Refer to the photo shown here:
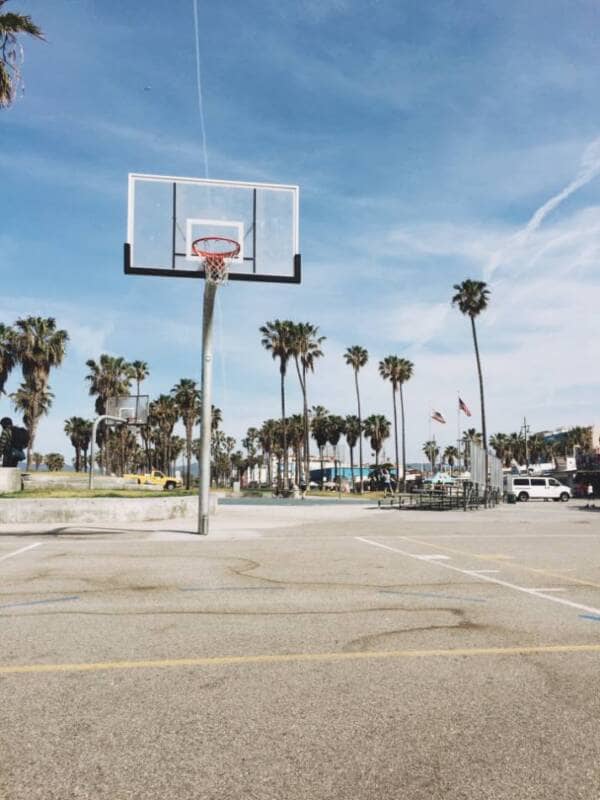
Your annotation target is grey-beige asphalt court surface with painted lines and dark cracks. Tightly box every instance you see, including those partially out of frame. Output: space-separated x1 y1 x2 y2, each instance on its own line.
0 503 600 800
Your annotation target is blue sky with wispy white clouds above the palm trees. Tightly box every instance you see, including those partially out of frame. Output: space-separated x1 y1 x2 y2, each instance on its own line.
0 0 600 460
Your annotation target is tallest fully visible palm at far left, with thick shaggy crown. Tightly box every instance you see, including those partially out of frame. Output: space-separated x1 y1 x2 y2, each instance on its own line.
13 317 69 469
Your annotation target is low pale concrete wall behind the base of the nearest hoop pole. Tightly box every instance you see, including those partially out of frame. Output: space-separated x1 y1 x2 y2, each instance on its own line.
0 495 217 524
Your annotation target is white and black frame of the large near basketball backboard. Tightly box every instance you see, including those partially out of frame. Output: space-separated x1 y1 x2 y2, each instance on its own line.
123 173 302 284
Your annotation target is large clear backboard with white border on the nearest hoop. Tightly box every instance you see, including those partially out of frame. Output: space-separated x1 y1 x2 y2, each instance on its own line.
125 174 301 283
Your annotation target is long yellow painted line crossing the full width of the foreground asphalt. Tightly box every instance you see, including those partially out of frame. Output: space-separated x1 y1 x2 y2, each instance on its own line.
0 644 600 675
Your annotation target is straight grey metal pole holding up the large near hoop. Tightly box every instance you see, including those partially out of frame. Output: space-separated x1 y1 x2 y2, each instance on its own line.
198 281 217 536
